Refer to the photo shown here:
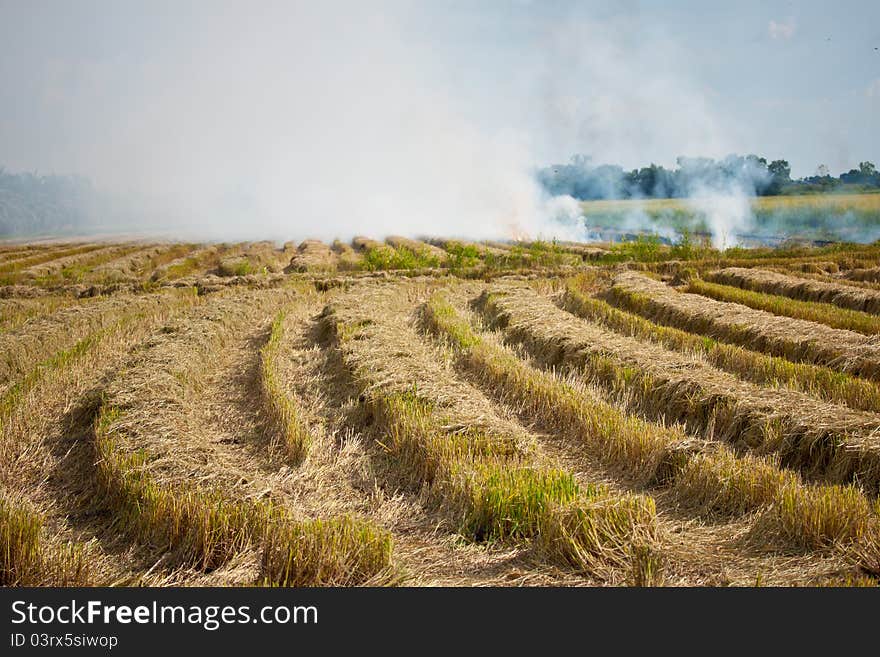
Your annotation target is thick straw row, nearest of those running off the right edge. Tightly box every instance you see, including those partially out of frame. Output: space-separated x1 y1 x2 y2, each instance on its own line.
481 287 880 493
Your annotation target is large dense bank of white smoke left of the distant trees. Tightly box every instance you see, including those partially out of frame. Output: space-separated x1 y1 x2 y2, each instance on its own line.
3 1 541 239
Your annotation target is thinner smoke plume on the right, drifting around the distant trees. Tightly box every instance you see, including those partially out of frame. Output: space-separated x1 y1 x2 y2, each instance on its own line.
524 12 759 246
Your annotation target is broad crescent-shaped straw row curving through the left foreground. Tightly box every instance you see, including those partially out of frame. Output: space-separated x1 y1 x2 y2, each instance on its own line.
96 288 393 586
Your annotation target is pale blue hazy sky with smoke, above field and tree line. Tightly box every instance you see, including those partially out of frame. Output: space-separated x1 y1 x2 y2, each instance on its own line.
0 0 880 236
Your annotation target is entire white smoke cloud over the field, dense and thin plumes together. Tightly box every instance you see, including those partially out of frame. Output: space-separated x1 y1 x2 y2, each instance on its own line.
0 2 784 239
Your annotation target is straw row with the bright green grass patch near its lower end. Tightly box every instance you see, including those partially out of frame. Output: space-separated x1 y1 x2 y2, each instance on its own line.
322 287 654 575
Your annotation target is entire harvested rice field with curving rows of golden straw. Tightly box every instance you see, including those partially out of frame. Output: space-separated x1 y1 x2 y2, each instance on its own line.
0 236 880 586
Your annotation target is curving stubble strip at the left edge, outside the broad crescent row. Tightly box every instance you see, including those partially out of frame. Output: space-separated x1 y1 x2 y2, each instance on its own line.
0 292 197 585
